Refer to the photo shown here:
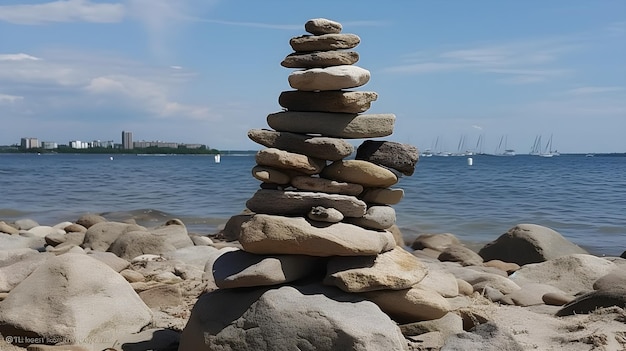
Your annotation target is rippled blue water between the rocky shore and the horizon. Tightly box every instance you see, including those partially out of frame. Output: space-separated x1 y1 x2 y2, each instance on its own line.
0 154 626 255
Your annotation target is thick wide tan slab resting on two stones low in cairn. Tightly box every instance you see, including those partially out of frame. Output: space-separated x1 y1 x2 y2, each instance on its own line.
239 214 396 257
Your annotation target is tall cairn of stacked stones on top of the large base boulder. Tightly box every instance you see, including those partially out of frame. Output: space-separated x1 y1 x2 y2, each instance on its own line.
182 19 448 349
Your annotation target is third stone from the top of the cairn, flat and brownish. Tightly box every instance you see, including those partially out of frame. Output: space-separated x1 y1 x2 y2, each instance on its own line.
280 51 359 68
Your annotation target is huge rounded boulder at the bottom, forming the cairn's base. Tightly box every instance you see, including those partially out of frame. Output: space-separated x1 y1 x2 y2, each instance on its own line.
179 285 406 351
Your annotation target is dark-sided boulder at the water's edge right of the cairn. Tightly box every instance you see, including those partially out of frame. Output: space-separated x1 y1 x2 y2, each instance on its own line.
478 224 587 265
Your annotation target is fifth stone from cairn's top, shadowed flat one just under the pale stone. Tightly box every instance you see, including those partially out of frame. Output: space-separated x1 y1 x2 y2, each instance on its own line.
278 90 378 113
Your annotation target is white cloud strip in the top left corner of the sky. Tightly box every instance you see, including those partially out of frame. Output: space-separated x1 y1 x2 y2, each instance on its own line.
0 0 125 25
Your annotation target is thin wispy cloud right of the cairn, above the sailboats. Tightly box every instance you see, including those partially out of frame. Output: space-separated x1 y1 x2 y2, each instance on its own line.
385 39 579 84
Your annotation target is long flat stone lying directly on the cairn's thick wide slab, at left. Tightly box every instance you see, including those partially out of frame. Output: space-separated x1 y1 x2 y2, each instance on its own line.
246 189 367 217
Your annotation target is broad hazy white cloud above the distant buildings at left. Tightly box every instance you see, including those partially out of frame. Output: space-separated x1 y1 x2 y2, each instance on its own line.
0 52 215 120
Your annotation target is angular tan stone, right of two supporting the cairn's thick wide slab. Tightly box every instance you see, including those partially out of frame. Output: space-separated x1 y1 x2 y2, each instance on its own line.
324 246 428 292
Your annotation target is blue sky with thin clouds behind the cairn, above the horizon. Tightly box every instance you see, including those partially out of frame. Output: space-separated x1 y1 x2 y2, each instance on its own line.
0 0 626 153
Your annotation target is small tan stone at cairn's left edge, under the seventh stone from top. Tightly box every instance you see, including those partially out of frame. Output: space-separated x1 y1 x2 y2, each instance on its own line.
256 148 326 174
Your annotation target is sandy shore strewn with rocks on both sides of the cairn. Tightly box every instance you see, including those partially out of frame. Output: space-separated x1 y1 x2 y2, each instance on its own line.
0 214 626 350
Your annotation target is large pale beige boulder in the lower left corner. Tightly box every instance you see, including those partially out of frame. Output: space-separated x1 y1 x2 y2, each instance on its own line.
0 254 152 343
